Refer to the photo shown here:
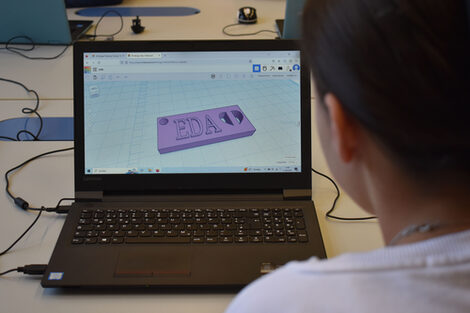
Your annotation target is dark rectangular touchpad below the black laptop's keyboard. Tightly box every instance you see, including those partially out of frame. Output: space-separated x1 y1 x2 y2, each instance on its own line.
114 250 191 277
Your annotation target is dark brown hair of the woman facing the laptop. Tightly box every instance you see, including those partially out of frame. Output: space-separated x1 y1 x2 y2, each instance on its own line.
303 0 470 178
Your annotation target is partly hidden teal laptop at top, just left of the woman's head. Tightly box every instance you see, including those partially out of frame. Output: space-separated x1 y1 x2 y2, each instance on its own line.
276 0 305 39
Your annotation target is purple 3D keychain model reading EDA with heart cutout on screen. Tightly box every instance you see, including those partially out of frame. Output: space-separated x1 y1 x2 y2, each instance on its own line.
157 105 256 154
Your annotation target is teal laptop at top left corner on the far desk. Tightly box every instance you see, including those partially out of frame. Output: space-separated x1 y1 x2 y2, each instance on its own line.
0 0 93 45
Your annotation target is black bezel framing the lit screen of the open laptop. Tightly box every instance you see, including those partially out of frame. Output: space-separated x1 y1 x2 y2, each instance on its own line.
74 40 311 193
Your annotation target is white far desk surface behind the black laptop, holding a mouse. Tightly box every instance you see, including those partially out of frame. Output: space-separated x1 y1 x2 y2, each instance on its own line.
0 0 285 99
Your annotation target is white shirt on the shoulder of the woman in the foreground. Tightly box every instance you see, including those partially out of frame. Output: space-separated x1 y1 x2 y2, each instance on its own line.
226 231 470 313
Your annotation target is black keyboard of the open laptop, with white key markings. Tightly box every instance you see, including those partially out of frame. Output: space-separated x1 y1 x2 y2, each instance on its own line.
72 208 308 245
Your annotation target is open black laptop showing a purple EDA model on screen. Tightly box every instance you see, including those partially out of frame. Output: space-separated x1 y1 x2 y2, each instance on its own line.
42 40 325 288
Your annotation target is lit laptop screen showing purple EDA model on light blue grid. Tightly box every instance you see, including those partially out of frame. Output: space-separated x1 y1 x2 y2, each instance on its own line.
82 50 302 175
